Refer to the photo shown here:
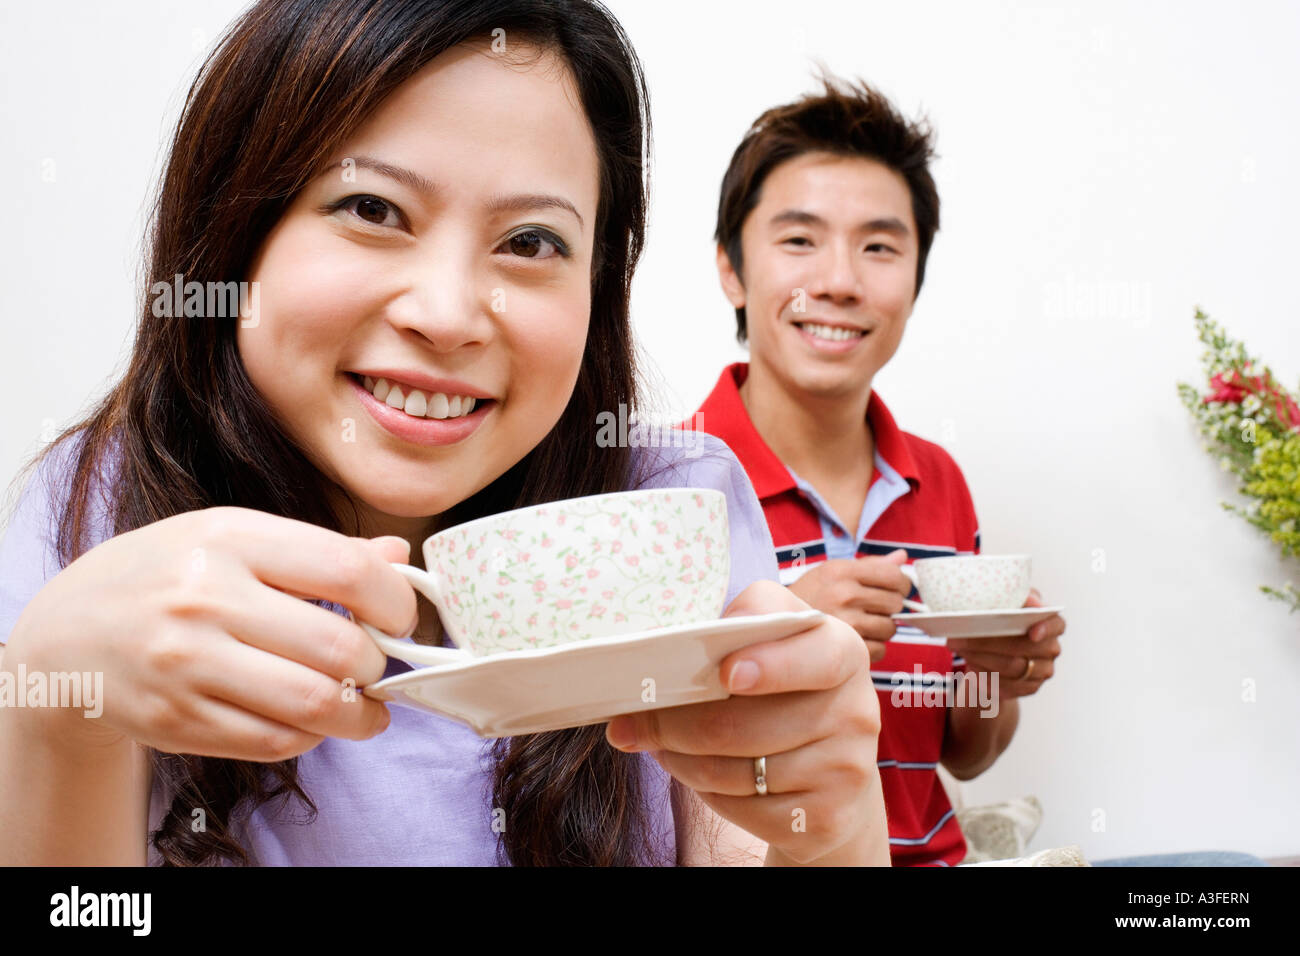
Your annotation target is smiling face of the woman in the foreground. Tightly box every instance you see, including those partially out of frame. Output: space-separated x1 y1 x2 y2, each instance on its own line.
238 47 599 540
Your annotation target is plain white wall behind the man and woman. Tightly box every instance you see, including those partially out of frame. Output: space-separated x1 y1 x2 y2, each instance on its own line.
0 0 1300 858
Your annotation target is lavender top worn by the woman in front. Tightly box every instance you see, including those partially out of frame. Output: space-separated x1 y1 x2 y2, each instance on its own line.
0 433 776 866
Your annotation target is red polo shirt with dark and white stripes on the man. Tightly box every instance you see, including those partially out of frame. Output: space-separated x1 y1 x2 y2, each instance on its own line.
686 363 979 866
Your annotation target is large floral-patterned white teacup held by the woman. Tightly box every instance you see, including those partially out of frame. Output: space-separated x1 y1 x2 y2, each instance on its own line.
358 488 731 663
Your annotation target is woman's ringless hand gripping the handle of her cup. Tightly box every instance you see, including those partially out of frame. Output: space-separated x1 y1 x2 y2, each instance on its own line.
5 507 416 762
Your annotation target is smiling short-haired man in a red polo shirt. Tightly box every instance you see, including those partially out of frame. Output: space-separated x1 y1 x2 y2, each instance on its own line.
697 81 1065 865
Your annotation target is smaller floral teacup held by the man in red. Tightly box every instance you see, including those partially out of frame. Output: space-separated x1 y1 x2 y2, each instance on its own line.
900 554 1030 613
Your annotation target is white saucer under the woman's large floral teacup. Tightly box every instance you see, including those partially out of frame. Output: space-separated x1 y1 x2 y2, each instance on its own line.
365 610 824 737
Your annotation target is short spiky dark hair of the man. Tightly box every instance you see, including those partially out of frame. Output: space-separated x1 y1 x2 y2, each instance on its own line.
714 74 939 345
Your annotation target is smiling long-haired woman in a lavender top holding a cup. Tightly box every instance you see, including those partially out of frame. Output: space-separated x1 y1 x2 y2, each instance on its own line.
0 0 888 865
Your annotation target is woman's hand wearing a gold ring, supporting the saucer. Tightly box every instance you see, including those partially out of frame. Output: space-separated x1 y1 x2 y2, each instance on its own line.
606 581 889 865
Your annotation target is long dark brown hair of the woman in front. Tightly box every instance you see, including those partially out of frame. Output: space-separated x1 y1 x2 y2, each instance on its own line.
26 0 671 865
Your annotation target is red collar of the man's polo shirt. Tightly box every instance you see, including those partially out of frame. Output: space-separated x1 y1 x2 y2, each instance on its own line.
686 362 920 498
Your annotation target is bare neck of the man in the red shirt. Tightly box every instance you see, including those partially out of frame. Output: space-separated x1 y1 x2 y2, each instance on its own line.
740 363 875 484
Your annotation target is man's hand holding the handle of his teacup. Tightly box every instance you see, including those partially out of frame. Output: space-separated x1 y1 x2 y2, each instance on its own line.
790 548 911 662
